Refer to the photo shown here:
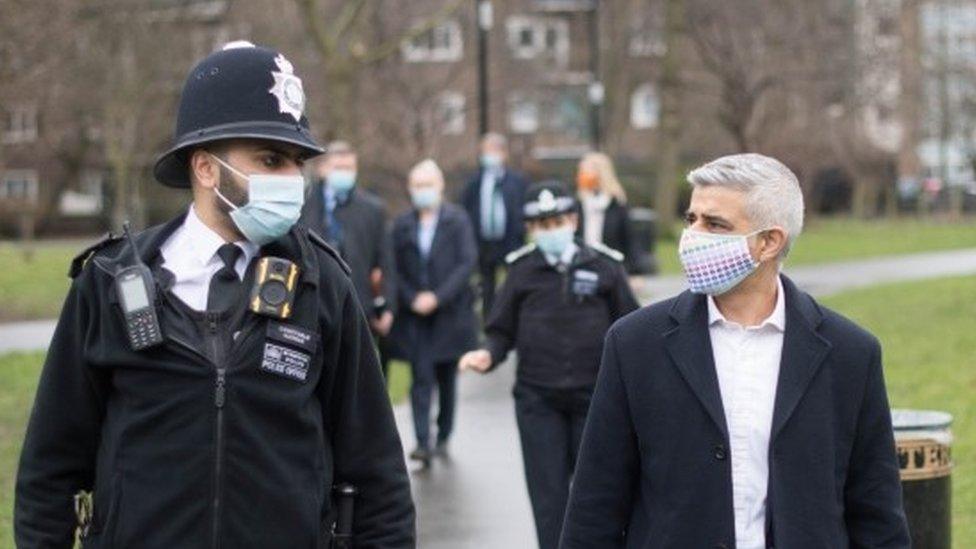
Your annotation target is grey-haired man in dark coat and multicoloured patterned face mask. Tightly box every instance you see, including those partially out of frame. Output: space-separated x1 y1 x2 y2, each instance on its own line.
560 154 910 549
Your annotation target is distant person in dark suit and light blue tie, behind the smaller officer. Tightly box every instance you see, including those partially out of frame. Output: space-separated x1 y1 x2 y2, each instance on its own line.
461 133 528 318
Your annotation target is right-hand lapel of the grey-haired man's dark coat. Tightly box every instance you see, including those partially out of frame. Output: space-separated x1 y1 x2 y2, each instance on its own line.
770 276 831 440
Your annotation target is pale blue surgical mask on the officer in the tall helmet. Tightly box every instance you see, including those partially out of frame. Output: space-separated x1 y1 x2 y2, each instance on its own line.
211 155 305 246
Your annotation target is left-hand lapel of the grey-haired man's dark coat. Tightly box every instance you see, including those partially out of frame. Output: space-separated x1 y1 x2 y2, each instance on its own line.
665 292 729 439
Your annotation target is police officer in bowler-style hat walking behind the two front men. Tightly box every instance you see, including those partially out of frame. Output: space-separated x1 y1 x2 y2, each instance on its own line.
459 181 637 549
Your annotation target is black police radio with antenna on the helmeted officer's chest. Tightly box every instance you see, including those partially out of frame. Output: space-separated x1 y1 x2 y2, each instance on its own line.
115 221 163 351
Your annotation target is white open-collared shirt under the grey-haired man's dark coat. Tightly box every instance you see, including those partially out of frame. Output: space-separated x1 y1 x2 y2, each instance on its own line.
708 280 786 549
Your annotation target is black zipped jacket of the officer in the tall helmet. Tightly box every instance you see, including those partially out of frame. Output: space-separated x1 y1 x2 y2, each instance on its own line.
14 214 414 549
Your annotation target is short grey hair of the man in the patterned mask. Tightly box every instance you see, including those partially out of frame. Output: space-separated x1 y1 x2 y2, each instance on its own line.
688 153 803 258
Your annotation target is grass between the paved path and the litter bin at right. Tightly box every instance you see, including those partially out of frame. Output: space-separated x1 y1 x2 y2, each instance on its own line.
824 277 976 548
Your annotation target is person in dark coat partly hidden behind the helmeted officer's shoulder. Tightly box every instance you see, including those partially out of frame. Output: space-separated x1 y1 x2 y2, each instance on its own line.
301 141 396 376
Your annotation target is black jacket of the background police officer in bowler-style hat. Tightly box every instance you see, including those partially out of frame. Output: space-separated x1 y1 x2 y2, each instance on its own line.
485 242 638 389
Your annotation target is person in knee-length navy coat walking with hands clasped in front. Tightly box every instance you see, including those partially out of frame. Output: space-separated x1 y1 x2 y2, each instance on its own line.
393 160 477 465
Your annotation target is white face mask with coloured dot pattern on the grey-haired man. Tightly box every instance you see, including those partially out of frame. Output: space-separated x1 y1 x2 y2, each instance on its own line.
678 229 765 295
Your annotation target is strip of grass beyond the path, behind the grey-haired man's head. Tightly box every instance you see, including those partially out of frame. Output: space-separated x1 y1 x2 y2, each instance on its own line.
657 218 976 274
